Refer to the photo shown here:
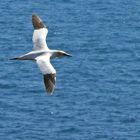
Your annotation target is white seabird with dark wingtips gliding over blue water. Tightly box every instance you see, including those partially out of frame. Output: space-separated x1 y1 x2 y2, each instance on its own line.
11 14 71 95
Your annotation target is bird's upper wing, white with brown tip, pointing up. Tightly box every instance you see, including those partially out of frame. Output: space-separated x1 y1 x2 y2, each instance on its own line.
32 14 49 51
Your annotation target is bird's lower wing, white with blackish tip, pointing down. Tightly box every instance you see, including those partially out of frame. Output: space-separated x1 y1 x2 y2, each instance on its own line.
36 55 56 95
